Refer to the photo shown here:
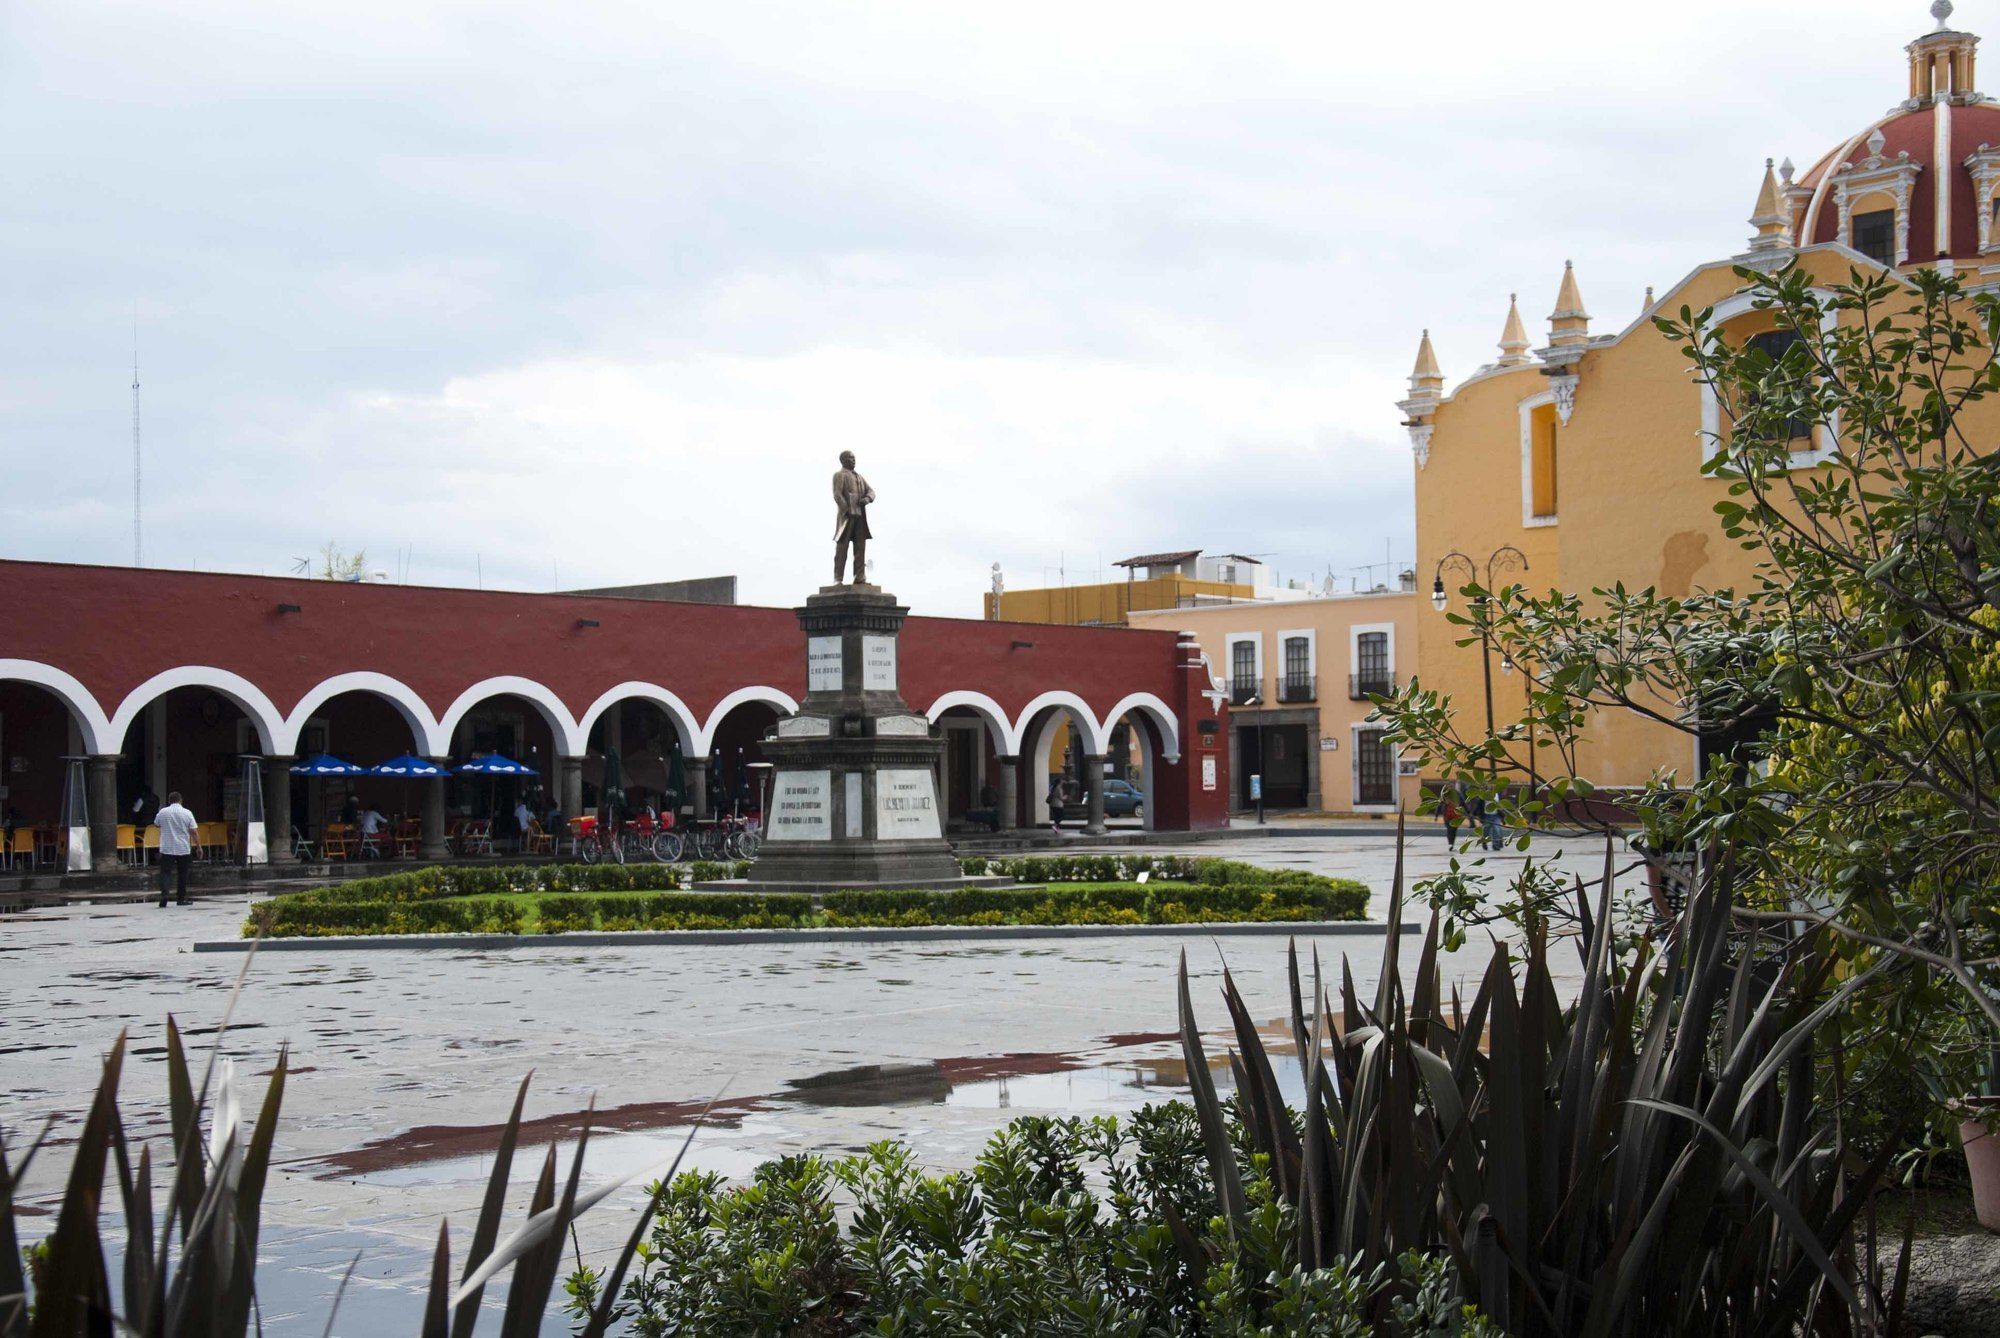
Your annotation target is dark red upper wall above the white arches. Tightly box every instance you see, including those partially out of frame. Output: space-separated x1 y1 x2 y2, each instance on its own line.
0 562 1228 828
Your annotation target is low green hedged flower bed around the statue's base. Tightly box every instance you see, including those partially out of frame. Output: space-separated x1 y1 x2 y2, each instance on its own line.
242 856 1368 938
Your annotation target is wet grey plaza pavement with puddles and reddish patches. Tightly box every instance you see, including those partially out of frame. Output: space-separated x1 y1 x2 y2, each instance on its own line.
0 832 1640 1334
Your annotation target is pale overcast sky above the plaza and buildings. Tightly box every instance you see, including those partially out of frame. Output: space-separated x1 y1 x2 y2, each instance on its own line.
0 0 1944 616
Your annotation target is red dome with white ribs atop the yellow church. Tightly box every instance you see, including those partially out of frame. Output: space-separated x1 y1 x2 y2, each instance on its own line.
1798 100 2000 264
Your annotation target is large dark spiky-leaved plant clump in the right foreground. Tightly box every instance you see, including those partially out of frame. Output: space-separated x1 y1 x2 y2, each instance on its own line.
1180 828 1900 1338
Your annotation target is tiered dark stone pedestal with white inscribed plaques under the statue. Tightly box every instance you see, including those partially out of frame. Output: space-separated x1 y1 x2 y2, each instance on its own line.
734 586 966 892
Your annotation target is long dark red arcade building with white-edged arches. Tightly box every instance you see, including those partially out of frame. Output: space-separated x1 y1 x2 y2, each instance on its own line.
0 562 1230 870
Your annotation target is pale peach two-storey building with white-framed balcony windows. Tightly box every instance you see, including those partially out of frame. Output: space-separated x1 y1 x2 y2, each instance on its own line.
1130 586 1422 814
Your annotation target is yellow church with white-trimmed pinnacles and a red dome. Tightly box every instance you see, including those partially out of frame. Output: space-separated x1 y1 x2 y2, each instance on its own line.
1398 0 2000 786
